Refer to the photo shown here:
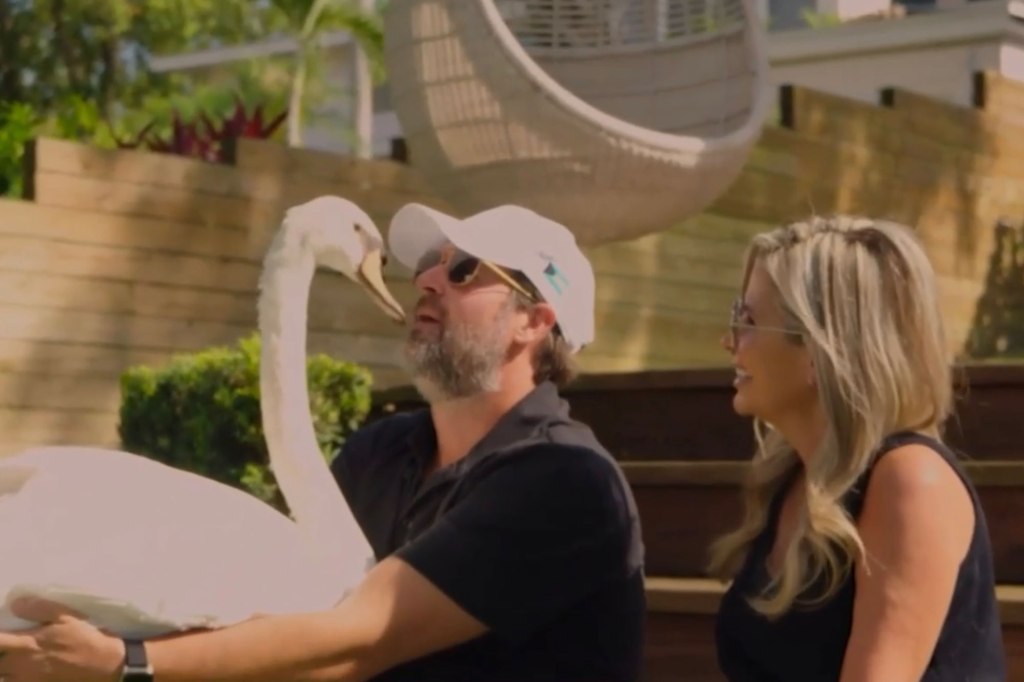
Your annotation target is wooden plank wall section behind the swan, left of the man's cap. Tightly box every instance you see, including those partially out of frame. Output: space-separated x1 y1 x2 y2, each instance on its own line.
0 139 444 453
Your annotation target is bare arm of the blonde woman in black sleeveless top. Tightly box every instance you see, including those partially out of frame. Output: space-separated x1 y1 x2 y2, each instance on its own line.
840 444 975 682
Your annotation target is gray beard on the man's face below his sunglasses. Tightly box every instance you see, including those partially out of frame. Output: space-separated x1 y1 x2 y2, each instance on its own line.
402 301 513 402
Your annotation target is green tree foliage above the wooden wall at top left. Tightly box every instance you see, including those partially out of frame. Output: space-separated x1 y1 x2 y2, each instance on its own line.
0 0 383 153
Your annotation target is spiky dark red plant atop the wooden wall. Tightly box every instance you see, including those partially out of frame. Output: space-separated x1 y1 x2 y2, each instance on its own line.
117 97 288 163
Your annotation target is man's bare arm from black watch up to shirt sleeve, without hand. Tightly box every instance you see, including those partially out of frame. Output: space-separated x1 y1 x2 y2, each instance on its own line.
105 558 486 682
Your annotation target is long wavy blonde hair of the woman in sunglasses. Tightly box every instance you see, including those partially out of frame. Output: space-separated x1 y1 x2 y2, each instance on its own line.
710 216 953 617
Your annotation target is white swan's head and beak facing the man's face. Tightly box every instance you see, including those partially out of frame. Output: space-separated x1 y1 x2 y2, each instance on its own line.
285 196 406 323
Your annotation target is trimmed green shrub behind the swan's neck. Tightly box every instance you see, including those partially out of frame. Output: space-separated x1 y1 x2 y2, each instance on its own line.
118 334 372 510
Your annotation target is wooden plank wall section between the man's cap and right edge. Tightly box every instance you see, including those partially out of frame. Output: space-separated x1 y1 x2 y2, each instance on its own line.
592 74 1024 369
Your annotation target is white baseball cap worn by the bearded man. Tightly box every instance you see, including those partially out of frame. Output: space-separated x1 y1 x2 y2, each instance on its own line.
388 204 595 352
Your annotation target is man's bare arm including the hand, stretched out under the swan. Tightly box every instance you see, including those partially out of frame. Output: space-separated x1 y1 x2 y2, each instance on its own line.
0 558 486 682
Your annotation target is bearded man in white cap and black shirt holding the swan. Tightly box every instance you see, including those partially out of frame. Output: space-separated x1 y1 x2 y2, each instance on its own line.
0 199 645 682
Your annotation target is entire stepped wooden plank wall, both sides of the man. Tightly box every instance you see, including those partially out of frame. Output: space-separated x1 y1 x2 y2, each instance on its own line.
0 74 1024 454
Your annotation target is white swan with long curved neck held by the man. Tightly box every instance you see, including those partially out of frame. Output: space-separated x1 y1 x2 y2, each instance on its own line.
0 197 403 637
